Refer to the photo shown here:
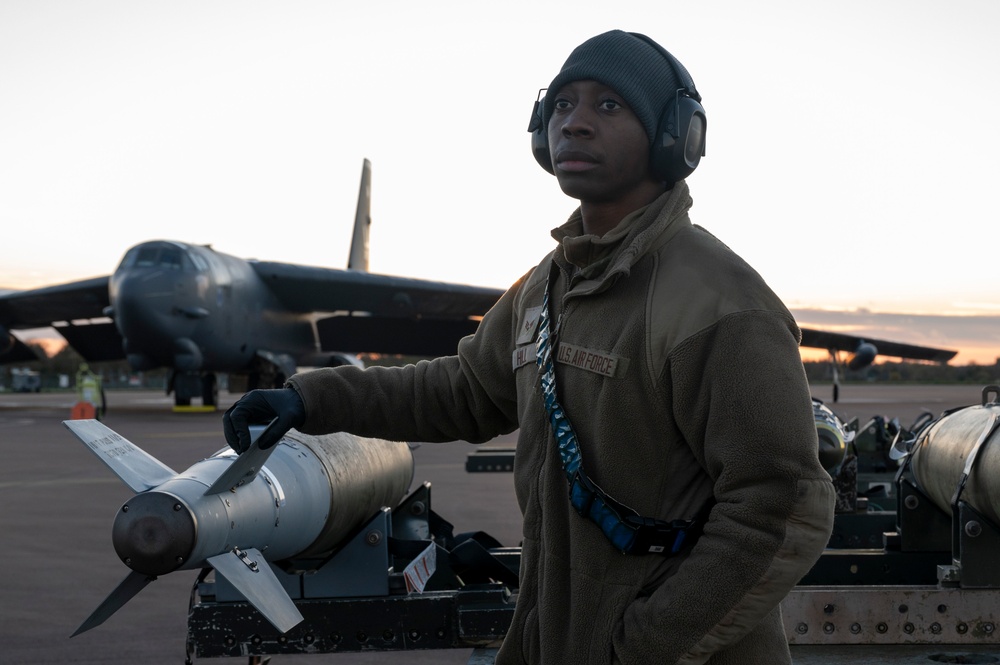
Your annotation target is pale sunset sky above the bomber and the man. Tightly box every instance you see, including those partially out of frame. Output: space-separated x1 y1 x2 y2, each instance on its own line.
0 0 1000 363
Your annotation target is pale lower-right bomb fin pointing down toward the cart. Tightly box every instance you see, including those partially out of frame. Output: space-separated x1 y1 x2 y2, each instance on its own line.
208 544 304 633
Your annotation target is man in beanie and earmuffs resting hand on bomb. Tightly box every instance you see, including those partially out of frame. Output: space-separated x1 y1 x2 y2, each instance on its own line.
225 30 834 665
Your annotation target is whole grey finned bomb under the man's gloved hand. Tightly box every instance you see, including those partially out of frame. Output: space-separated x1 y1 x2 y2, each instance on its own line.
63 420 414 636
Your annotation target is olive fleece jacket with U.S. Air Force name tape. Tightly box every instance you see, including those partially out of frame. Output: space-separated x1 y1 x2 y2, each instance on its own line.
289 182 834 665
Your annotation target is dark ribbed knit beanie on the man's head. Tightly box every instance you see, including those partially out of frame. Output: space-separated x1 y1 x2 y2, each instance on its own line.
542 30 682 145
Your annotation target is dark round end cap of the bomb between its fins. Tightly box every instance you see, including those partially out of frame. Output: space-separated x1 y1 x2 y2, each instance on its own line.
111 492 197 576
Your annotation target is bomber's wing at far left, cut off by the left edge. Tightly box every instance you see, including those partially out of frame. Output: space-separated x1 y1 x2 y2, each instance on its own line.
0 276 125 363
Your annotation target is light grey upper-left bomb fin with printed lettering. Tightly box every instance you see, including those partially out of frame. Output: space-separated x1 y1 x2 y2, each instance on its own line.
63 420 177 494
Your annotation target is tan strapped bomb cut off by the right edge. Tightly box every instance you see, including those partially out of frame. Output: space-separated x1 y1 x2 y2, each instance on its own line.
910 386 1000 524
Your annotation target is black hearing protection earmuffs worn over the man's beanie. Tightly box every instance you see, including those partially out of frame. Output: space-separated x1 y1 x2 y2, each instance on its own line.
528 37 707 184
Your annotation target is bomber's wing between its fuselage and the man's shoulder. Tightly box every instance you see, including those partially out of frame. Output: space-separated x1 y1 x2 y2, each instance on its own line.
252 262 503 355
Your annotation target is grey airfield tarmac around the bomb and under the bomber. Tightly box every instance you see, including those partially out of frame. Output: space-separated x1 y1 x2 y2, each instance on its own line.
0 385 1000 665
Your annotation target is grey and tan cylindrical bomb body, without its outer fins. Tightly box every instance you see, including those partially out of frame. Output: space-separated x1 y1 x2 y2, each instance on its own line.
112 432 413 575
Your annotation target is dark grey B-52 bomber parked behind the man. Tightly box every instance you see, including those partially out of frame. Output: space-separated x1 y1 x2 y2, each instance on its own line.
0 159 956 407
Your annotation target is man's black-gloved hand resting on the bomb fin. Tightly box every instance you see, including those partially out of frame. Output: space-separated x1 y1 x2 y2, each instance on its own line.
222 388 306 454
